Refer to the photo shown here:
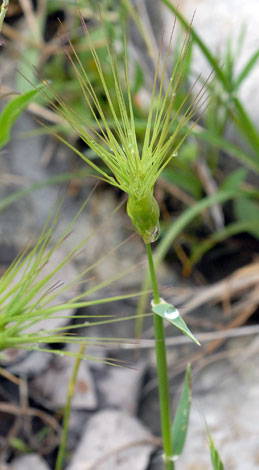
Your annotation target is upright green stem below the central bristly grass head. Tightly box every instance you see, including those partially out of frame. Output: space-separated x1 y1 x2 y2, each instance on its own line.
146 243 174 470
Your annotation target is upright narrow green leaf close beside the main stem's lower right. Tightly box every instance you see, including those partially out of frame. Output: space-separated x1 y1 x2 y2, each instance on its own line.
172 364 192 460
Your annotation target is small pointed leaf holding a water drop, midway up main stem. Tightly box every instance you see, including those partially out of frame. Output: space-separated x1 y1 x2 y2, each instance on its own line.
152 299 200 346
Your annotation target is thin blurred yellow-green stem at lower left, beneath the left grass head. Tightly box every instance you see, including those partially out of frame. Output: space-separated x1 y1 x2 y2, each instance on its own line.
55 343 86 470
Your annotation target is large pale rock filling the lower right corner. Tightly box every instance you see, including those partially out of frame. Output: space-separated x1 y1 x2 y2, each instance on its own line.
177 350 259 470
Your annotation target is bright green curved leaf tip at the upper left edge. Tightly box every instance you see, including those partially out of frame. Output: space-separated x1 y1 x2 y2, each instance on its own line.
0 88 39 148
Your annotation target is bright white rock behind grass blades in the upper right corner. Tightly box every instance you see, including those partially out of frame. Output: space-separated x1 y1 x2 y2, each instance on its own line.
163 0 259 124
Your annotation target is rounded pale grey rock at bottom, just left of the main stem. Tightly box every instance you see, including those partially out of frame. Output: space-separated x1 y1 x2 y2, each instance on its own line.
67 408 154 470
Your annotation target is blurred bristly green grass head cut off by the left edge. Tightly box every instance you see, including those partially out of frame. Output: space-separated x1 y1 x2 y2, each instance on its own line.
0 193 144 364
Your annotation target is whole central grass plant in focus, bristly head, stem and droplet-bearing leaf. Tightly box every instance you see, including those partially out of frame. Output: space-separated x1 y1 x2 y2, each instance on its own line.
42 6 211 470
